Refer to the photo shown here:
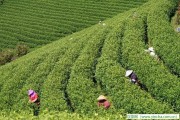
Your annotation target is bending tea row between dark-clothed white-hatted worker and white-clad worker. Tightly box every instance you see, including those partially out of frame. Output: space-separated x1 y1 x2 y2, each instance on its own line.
122 10 180 111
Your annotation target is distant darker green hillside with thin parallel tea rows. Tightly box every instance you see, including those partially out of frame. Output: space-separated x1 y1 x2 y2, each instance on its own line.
0 0 147 50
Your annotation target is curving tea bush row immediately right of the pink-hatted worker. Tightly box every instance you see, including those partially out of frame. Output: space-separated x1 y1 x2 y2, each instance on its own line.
41 25 100 111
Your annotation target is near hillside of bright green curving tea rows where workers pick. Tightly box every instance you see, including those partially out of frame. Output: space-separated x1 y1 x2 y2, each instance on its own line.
0 0 180 119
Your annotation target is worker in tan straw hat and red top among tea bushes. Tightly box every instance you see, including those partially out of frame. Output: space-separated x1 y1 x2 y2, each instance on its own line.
97 95 111 109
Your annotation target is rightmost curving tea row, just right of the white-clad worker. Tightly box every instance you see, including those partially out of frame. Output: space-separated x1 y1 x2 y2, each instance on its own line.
147 0 180 76
